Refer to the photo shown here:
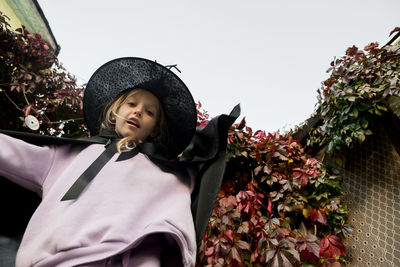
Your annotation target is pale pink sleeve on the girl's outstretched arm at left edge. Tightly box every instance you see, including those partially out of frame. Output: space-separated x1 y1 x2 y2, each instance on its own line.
0 134 55 195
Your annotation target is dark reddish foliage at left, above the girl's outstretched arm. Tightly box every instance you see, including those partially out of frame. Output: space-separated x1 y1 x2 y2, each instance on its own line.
0 12 86 136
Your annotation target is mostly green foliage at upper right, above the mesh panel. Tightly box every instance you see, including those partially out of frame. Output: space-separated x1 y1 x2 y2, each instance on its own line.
308 28 400 152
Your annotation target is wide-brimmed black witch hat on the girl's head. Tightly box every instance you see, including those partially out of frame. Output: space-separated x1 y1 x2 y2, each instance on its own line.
83 57 197 156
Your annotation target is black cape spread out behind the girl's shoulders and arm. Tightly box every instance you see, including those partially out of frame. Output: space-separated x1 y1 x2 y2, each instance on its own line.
0 105 240 258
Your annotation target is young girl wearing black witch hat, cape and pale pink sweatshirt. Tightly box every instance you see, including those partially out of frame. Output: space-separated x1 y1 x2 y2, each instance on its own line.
0 58 238 267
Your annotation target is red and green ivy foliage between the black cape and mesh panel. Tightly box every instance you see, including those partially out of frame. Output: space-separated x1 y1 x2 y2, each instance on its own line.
198 119 351 266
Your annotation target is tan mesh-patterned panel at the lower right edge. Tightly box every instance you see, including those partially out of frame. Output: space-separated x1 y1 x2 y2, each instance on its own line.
328 124 400 267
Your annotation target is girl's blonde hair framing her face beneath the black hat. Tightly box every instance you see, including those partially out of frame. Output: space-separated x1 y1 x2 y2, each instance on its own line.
100 88 167 153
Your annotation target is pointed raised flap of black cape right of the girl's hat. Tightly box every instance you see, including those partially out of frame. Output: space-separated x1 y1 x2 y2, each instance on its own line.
181 105 240 248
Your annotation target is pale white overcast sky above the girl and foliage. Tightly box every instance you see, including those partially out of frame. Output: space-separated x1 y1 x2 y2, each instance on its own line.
38 0 400 132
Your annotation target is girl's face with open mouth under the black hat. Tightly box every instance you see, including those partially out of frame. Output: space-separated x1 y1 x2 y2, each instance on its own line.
113 89 161 141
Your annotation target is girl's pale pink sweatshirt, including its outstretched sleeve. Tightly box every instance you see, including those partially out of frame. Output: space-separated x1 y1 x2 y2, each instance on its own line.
0 134 196 267
